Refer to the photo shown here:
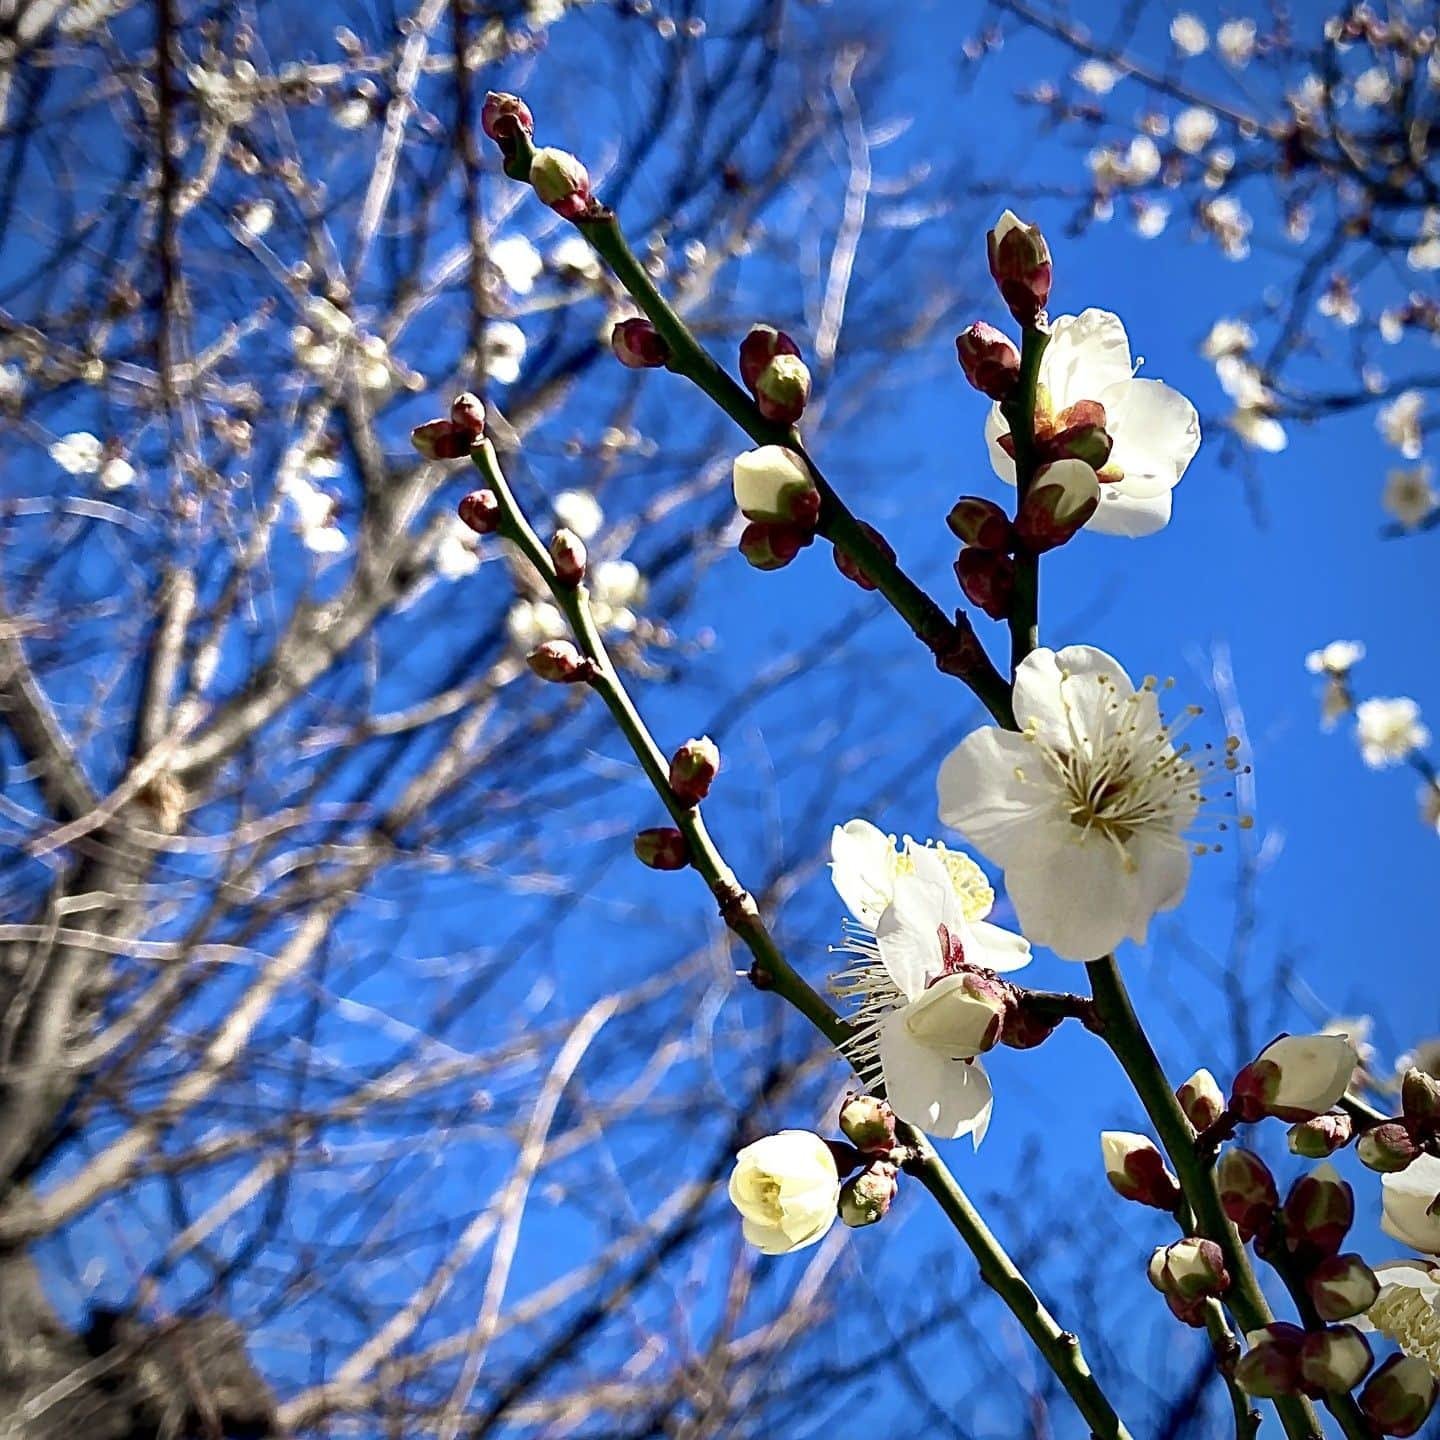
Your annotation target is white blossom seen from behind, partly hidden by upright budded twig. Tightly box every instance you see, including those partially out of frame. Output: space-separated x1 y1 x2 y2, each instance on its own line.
985 310 1200 536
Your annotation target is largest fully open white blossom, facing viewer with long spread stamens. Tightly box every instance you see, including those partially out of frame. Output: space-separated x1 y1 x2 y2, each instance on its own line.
937 645 1209 960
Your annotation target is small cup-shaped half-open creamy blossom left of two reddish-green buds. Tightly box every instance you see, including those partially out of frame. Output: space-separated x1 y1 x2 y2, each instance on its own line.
729 1130 840 1256
